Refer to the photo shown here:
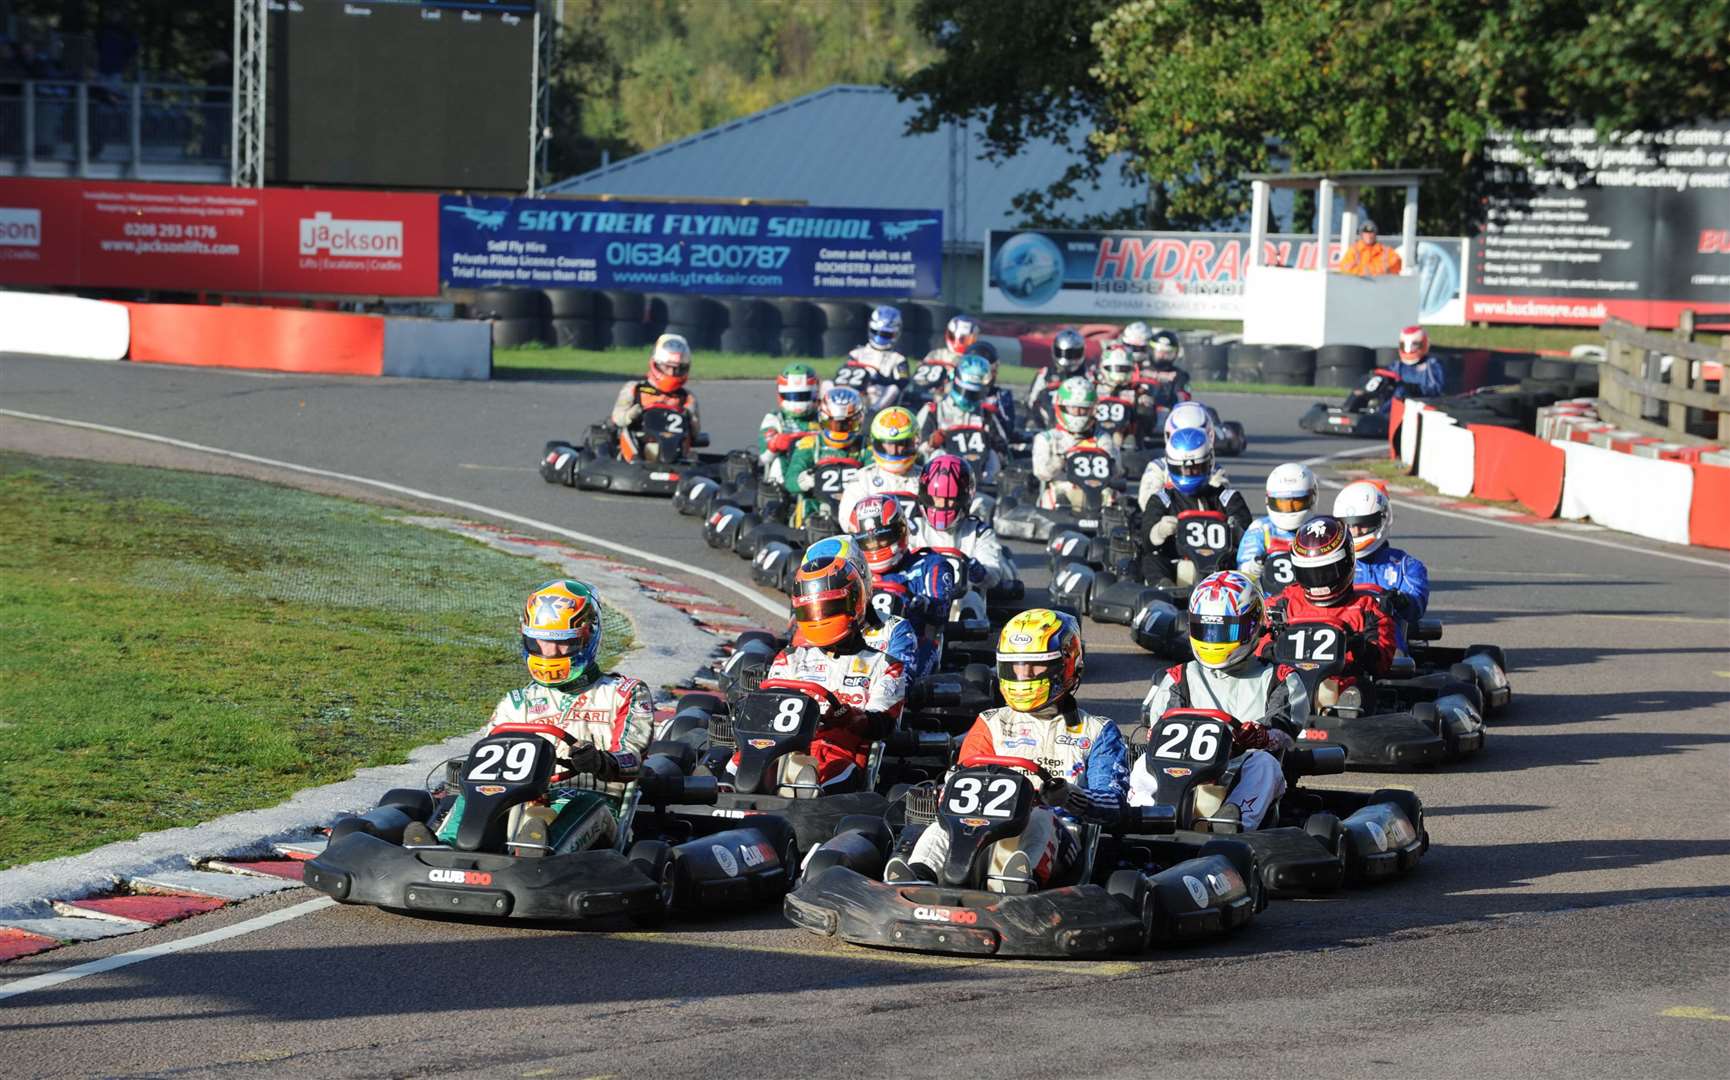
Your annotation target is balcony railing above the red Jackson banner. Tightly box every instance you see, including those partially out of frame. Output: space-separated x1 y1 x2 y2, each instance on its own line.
0 80 232 177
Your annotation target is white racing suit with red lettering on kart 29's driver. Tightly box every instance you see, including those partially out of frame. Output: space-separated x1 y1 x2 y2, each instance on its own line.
438 668 654 850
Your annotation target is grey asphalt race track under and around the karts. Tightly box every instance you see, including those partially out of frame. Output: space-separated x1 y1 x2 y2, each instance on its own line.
0 357 1730 1078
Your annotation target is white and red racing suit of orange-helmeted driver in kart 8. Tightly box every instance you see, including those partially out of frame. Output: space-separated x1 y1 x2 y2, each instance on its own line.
765 616 919 788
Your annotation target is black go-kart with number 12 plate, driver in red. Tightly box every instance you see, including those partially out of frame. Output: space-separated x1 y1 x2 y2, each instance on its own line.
1270 611 1484 765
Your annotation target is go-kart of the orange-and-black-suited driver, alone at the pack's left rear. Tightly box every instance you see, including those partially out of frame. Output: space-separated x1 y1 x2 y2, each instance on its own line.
540 405 727 495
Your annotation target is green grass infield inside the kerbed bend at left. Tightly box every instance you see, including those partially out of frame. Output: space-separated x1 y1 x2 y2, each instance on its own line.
0 453 630 867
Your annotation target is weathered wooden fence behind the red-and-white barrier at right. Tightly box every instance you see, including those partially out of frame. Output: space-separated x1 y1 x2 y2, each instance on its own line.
1599 312 1730 447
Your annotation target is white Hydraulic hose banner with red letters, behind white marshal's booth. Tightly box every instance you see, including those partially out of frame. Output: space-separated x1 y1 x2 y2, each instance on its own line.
984 228 1465 325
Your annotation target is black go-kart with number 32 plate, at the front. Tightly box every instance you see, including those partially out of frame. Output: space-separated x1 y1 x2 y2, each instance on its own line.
784 756 1265 957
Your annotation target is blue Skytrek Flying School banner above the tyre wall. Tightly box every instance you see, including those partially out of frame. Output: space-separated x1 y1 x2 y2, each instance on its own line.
439 196 943 298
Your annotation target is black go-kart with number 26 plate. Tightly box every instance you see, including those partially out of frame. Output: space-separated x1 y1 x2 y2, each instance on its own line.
1142 708 1429 897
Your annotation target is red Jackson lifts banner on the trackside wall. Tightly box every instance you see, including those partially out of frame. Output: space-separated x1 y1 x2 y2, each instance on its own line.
0 180 439 296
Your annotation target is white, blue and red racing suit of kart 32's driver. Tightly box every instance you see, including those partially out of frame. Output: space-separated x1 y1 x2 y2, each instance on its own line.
908 698 1130 888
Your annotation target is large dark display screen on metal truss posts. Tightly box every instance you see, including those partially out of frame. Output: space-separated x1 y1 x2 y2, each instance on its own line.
266 0 535 190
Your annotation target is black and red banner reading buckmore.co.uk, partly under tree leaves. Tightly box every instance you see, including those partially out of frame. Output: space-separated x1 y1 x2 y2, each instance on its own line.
1467 125 1730 327
